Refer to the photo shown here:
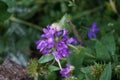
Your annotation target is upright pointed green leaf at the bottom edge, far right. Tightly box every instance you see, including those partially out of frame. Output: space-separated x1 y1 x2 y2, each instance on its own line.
99 63 112 80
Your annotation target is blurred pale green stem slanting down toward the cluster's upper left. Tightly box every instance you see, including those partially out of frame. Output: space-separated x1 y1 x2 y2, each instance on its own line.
10 16 42 31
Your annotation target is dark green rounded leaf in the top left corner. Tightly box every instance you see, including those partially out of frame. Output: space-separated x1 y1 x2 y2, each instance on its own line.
0 1 11 22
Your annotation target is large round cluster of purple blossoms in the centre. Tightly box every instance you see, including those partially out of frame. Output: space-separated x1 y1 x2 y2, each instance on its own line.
36 25 74 61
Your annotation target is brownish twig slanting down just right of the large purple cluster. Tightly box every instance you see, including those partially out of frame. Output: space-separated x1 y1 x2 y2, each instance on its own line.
67 20 82 43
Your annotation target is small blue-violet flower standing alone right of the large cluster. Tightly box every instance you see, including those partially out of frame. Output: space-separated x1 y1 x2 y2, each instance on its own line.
88 22 99 38
